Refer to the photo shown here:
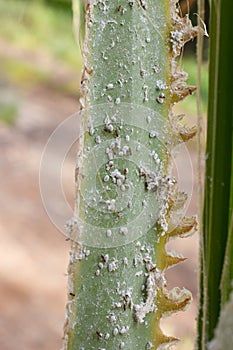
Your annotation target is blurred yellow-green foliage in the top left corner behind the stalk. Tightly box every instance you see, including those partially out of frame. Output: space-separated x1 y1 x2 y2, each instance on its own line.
0 0 81 69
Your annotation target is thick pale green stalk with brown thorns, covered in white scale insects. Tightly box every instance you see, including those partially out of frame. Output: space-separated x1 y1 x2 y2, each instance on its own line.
64 0 196 350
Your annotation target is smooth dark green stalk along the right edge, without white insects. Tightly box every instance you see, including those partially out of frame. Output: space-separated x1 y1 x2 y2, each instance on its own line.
199 0 233 349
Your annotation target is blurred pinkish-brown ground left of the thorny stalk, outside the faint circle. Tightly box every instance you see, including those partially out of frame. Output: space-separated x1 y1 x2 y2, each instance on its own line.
0 82 77 350
